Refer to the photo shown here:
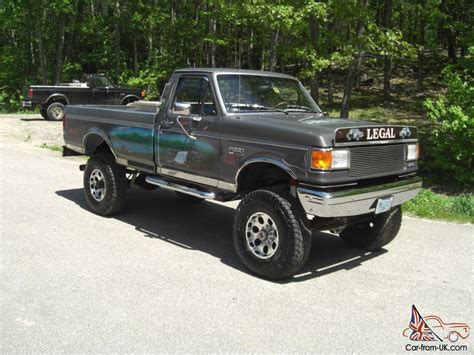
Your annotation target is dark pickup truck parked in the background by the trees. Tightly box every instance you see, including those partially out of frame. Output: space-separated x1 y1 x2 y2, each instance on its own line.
22 74 144 121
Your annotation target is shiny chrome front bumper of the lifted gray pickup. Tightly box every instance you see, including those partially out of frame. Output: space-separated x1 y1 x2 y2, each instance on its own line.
296 177 422 217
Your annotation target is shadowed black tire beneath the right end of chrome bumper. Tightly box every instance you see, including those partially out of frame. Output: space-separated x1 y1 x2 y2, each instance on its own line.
340 206 402 250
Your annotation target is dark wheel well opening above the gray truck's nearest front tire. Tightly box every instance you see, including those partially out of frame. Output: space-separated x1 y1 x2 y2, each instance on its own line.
237 163 292 193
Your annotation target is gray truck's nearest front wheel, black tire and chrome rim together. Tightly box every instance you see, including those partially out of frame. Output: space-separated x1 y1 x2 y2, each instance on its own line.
234 190 311 279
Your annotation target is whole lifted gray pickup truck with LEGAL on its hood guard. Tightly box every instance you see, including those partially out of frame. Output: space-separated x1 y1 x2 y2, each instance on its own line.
64 69 421 279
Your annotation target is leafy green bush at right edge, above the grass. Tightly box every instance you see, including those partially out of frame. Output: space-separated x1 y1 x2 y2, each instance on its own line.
423 63 474 190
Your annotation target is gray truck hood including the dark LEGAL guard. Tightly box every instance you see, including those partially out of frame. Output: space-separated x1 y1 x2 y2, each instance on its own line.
231 113 417 147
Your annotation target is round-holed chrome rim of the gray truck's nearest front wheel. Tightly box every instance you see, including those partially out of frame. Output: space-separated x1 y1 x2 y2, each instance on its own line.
245 212 279 259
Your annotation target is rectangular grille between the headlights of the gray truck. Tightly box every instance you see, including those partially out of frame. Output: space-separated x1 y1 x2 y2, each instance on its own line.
349 144 405 177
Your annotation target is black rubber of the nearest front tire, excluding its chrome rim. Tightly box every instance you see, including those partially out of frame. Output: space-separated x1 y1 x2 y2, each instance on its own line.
234 190 311 280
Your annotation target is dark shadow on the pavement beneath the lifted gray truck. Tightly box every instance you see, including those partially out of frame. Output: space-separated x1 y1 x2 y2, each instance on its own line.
56 188 386 284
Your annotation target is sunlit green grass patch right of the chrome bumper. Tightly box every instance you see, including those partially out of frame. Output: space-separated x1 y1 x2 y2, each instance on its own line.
402 189 474 223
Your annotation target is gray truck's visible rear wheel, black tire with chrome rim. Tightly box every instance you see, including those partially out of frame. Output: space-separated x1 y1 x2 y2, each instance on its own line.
84 154 127 216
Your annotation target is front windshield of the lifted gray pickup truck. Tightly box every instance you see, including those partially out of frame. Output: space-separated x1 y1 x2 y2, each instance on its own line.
217 74 321 113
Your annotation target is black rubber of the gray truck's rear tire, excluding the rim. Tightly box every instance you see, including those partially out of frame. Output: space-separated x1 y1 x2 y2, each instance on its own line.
84 153 128 216
